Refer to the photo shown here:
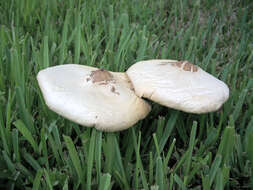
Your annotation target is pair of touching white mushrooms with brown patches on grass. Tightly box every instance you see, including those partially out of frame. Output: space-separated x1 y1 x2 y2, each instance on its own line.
37 60 229 131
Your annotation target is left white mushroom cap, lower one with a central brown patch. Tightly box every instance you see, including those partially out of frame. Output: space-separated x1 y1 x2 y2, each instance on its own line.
37 64 150 131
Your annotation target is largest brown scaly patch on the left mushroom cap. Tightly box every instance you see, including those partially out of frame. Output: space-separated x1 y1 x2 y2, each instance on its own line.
90 69 113 85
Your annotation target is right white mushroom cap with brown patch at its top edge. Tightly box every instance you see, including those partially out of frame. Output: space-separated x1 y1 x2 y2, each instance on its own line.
127 60 229 113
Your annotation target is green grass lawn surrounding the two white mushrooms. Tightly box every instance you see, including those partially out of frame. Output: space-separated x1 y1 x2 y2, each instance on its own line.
0 0 253 190
